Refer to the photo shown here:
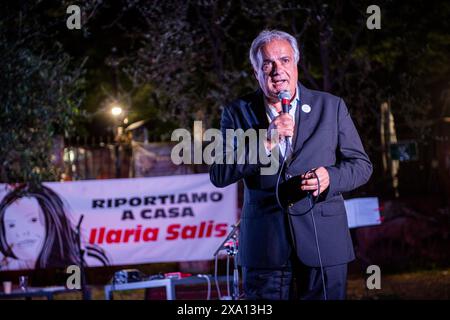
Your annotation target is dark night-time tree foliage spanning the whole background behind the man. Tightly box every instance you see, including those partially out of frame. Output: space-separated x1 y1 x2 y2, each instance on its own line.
0 0 450 190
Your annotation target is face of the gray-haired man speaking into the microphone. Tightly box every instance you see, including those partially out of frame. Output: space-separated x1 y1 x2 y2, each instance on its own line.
255 40 298 102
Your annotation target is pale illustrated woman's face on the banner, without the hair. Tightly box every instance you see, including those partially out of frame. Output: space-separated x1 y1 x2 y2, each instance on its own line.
4 198 45 260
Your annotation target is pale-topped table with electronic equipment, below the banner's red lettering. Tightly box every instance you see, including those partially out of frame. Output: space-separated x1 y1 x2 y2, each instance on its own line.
104 276 227 300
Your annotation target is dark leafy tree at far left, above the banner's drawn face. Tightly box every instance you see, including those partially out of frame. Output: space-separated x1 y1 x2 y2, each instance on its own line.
0 2 83 183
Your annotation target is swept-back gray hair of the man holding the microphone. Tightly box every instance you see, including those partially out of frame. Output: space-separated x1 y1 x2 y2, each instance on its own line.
250 30 300 70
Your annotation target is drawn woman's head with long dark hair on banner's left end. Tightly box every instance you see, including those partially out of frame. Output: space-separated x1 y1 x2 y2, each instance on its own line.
0 184 110 270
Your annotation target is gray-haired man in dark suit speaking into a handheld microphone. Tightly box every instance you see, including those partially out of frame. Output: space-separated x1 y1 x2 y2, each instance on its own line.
210 30 372 299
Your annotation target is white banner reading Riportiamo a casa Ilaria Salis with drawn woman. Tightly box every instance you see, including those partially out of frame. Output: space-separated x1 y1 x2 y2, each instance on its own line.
0 174 237 270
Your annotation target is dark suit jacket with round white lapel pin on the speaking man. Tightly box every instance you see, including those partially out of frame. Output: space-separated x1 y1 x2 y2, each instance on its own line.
210 84 372 268
